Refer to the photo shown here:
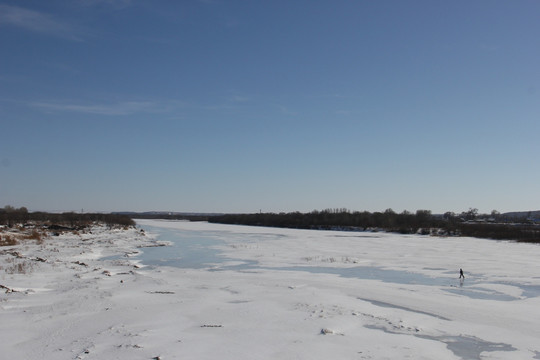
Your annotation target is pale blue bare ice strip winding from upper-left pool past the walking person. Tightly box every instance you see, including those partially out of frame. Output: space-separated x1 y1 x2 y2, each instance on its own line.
139 225 540 301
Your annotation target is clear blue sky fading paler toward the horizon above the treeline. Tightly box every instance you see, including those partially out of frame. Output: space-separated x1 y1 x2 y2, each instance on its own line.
0 0 540 213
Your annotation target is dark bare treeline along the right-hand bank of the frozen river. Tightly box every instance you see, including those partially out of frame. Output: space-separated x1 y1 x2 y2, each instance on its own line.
208 209 540 242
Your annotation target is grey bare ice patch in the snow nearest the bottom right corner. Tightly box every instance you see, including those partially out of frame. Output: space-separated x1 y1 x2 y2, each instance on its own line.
365 325 517 360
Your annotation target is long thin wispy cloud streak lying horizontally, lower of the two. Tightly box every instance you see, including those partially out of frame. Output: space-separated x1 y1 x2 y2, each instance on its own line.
31 101 167 116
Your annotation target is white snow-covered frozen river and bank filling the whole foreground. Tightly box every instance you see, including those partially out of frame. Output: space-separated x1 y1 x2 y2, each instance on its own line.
0 220 540 360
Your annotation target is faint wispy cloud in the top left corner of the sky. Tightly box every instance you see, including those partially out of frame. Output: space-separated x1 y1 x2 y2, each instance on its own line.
0 4 82 41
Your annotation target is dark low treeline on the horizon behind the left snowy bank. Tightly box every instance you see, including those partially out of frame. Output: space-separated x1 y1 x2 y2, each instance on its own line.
0 206 135 228
